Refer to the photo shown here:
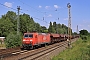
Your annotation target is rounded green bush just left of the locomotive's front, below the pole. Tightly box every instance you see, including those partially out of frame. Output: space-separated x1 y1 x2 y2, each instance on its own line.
5 33 21 48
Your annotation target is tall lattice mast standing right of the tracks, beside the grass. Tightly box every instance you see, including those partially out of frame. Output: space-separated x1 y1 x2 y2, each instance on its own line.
67 3 71 44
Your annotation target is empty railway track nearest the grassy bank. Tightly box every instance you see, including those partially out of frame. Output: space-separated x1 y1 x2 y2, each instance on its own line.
19 41 66 60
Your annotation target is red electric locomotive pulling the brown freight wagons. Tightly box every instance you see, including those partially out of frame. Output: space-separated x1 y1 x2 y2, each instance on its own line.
22 32 51 49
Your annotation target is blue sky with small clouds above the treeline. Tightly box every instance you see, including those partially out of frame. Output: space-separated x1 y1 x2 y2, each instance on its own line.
0 0 90 32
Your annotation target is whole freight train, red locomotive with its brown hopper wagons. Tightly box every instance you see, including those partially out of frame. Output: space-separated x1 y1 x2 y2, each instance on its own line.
22 32 79 49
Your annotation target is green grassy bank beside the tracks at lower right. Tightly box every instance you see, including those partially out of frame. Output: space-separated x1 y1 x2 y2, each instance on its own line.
52 37 90 60
